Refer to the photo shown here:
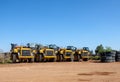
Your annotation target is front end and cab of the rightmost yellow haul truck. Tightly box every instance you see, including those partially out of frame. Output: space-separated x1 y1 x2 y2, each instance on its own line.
81 47 90 61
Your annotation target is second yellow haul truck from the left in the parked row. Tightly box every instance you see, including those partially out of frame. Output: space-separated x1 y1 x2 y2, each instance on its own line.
35 45 56 62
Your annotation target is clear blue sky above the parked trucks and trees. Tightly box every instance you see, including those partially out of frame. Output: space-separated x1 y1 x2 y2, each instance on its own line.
0 0 120 51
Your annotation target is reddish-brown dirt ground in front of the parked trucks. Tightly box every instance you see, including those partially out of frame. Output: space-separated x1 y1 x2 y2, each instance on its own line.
0 62 120 82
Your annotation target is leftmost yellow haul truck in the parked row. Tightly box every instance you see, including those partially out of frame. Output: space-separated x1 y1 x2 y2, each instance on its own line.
11 44 34 63
